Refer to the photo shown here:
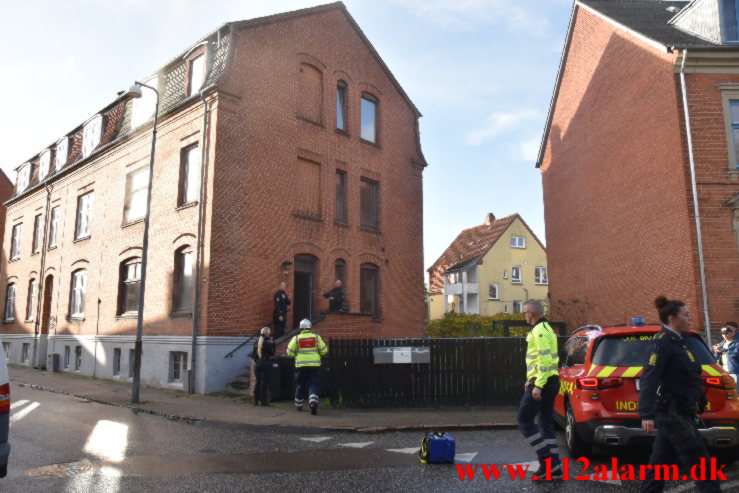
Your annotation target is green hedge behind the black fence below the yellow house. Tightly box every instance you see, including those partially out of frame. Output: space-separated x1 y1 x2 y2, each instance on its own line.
425 312 528 337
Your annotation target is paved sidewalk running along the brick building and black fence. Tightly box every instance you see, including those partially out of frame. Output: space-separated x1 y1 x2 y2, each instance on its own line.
8 365 516 433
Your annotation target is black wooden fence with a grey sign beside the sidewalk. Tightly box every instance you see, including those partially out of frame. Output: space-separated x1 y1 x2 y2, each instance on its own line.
328 337 567 407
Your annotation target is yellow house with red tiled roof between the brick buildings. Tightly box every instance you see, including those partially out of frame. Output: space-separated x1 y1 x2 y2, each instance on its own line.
428 213 549 319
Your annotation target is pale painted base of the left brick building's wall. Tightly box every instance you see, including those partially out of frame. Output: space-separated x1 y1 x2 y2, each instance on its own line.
0 334 252 394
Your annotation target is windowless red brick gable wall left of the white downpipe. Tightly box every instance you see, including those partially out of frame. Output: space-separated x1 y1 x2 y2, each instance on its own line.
541 9 702 327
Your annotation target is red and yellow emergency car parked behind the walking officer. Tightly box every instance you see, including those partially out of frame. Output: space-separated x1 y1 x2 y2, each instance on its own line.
554 324 739 457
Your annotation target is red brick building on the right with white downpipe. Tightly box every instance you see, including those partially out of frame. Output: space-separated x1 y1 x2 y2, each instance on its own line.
537 0 739 338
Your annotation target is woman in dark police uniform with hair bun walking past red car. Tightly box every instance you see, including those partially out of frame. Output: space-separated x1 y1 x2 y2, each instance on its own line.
639 296 721 493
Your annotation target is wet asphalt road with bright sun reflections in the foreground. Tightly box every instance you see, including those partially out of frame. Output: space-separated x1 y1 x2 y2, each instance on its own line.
0 386 739 493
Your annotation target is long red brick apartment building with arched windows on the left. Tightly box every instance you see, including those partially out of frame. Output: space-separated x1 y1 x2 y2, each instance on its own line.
2 2 426 392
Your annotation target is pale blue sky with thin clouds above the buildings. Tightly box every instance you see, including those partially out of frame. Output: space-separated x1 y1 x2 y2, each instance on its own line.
0 0 572 267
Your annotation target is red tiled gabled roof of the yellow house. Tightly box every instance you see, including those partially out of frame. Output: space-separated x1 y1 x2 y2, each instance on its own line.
428 214 544 272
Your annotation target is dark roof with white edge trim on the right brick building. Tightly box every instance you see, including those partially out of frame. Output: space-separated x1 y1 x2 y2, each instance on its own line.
536 0 739 168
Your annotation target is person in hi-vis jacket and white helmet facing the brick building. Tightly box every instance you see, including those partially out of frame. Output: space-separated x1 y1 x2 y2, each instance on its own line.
287 318 328 414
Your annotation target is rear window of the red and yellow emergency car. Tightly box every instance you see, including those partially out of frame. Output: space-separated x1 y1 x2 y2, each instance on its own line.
593 334 716 366
